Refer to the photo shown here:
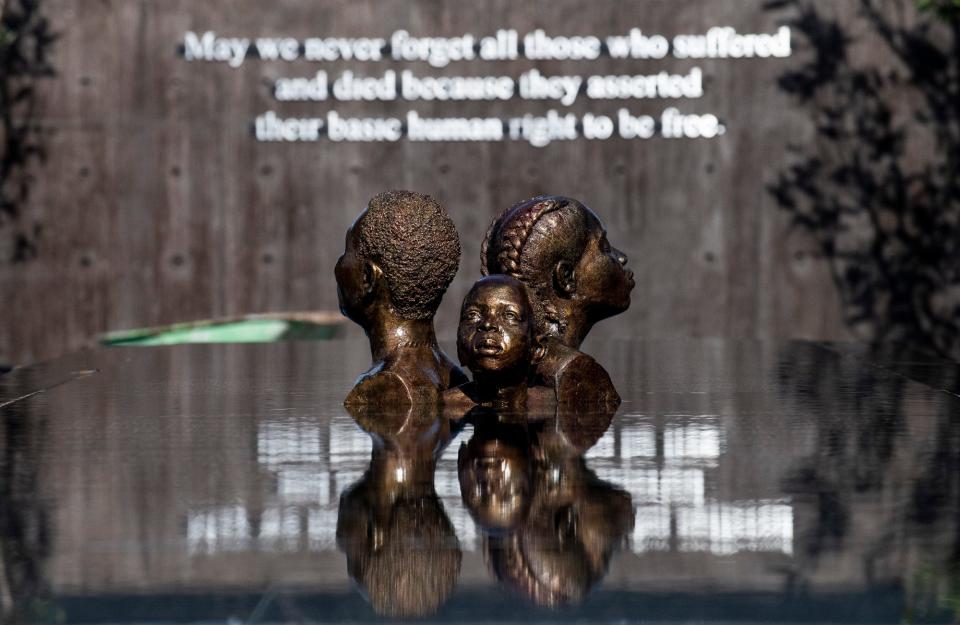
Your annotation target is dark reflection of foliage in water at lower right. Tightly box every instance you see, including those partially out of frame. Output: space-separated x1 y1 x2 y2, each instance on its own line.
777 343 960 623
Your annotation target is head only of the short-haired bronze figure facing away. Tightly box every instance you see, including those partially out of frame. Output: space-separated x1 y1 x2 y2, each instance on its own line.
335 191 460 327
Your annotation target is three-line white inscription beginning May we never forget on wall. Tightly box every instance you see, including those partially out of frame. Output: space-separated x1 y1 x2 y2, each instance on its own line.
182 26 792 147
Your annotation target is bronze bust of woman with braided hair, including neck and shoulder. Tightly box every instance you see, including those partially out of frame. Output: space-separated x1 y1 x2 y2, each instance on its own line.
481 196 634 403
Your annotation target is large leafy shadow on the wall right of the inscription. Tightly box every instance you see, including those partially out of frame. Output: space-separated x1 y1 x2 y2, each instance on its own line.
765 0 960 359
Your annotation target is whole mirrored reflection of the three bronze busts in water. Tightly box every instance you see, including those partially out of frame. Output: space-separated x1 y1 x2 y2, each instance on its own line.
337 392 634 617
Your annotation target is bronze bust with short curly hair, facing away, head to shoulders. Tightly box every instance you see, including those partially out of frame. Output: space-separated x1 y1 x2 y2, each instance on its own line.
335 191 467 404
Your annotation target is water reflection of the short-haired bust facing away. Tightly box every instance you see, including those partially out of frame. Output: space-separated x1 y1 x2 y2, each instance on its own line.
337 404 461 618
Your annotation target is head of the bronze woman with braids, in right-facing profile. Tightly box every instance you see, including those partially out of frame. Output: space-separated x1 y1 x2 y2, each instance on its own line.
481 196 634 347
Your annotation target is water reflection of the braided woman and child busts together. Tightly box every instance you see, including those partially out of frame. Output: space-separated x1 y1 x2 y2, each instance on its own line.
458 408 634 607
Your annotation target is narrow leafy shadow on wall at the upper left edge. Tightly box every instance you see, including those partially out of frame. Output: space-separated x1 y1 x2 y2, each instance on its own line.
0 0 56 263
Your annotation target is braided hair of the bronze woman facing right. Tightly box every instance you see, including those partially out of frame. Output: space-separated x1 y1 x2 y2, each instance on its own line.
480 195 587 336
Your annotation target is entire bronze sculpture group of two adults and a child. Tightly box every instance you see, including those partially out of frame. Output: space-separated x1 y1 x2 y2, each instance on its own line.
336 191 634 414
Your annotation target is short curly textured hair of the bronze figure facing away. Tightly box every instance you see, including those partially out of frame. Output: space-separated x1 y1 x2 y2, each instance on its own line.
356 191 460 319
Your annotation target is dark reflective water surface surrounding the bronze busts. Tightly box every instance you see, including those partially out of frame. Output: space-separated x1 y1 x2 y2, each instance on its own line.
0 341 960 623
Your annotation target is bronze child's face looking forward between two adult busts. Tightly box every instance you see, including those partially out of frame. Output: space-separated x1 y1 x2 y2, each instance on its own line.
457 276 533 372
